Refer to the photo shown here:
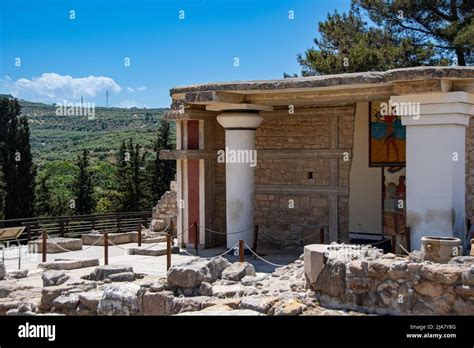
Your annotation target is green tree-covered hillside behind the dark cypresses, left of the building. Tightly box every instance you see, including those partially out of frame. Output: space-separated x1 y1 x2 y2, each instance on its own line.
5 100 175 216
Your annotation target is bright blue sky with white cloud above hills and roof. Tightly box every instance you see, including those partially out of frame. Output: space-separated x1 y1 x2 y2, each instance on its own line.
0 0 350 107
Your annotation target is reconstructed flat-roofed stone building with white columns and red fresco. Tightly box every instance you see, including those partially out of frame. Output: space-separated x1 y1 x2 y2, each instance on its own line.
160 67 474 253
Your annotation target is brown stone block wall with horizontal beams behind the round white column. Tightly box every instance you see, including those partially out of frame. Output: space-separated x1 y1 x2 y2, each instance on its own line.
208 104 355 249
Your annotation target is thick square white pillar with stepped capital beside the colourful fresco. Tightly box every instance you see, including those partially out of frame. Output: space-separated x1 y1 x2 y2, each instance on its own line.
391 92 474 249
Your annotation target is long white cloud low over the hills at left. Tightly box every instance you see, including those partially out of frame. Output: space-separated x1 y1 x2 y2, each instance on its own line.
1 73 122 102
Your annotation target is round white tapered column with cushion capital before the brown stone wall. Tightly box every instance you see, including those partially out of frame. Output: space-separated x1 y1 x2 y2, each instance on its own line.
217 111 263 248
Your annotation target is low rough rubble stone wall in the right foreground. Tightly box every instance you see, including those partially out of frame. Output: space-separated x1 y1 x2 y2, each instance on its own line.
305 244 474 315
